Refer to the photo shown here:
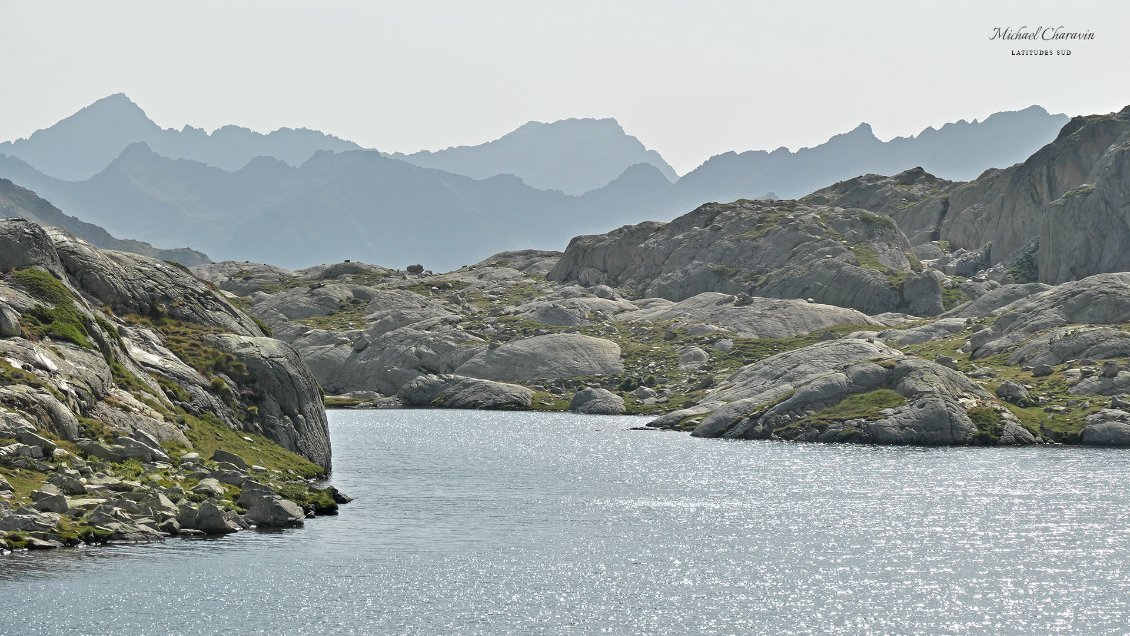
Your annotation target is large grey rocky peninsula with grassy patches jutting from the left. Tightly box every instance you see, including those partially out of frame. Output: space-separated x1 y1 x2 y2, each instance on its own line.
0 219 348 552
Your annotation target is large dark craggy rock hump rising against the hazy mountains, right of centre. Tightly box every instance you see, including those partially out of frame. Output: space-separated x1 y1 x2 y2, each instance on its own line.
548 201 940 314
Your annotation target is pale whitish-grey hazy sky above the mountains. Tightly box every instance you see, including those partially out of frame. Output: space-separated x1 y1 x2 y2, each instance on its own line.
0 0 1130 174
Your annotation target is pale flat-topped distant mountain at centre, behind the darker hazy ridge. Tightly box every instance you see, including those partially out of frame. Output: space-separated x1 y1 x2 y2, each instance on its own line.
392 119 678 194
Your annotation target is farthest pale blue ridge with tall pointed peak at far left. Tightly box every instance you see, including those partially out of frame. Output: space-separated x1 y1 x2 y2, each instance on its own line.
0 93 359 181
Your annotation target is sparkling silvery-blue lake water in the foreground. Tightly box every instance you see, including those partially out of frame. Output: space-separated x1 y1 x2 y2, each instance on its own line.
0 411 1130 635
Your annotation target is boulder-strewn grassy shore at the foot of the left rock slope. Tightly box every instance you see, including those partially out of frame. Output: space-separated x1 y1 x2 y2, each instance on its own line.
0 436 350 555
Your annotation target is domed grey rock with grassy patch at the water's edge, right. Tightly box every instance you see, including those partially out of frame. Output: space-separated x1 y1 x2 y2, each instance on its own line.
651 339 1035 445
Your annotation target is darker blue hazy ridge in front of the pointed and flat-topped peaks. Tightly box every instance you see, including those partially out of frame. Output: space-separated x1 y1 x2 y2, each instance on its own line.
0 143 670 270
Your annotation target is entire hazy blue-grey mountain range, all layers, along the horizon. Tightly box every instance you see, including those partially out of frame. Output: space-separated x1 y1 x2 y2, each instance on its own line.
0 95 1067 270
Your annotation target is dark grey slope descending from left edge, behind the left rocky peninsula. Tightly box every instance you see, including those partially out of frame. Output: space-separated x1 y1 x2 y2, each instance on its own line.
0 178 209 265
